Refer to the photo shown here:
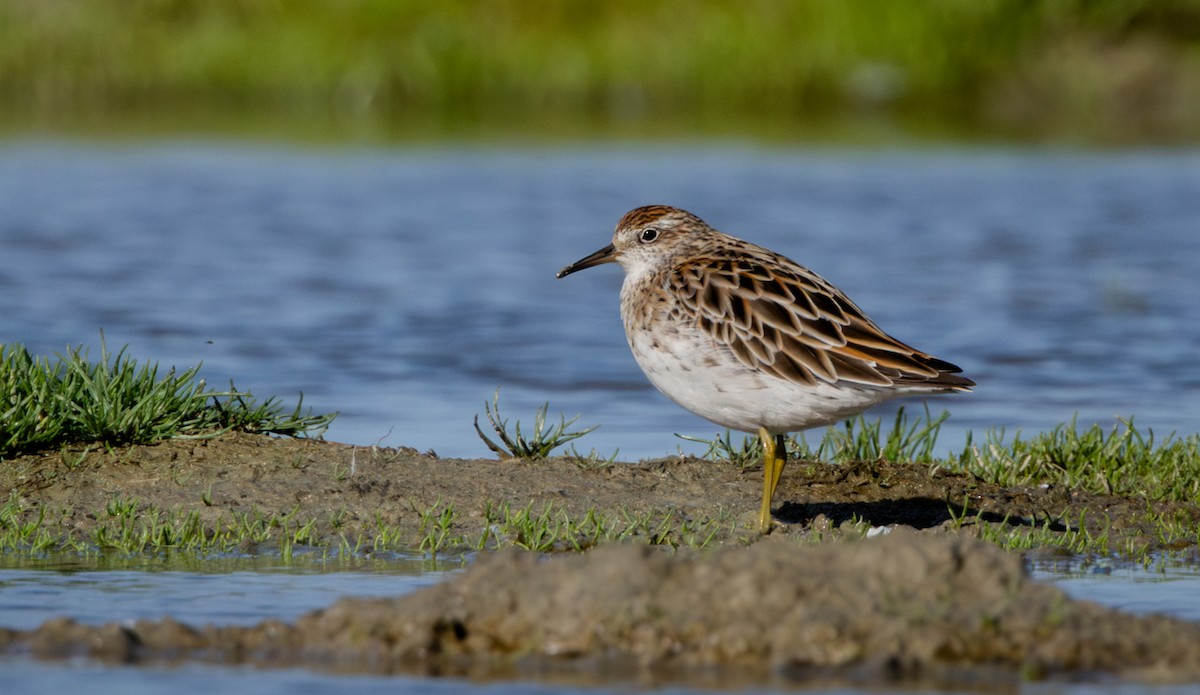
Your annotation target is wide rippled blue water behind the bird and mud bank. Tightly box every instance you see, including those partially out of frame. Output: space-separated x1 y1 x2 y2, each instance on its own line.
0 140 1200 460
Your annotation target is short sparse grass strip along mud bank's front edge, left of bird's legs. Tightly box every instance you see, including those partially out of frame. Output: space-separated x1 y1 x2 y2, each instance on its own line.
0 496 738 563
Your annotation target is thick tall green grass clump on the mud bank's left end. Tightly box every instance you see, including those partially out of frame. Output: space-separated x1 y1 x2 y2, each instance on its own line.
0 341 336 459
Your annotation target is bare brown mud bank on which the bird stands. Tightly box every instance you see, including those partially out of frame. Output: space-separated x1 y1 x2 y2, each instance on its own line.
0 435 1200 552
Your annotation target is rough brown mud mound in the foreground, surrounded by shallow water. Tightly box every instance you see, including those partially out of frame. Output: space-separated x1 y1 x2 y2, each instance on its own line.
0 531 1200 684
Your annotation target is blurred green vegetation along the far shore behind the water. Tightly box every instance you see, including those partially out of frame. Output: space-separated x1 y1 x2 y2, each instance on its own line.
0 0 1200 140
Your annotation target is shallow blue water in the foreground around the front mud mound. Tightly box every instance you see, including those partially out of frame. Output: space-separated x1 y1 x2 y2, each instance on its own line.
0 558 1200 695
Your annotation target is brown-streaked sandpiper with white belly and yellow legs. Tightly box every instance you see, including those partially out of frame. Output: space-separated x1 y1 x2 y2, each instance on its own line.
557 205 976 534
